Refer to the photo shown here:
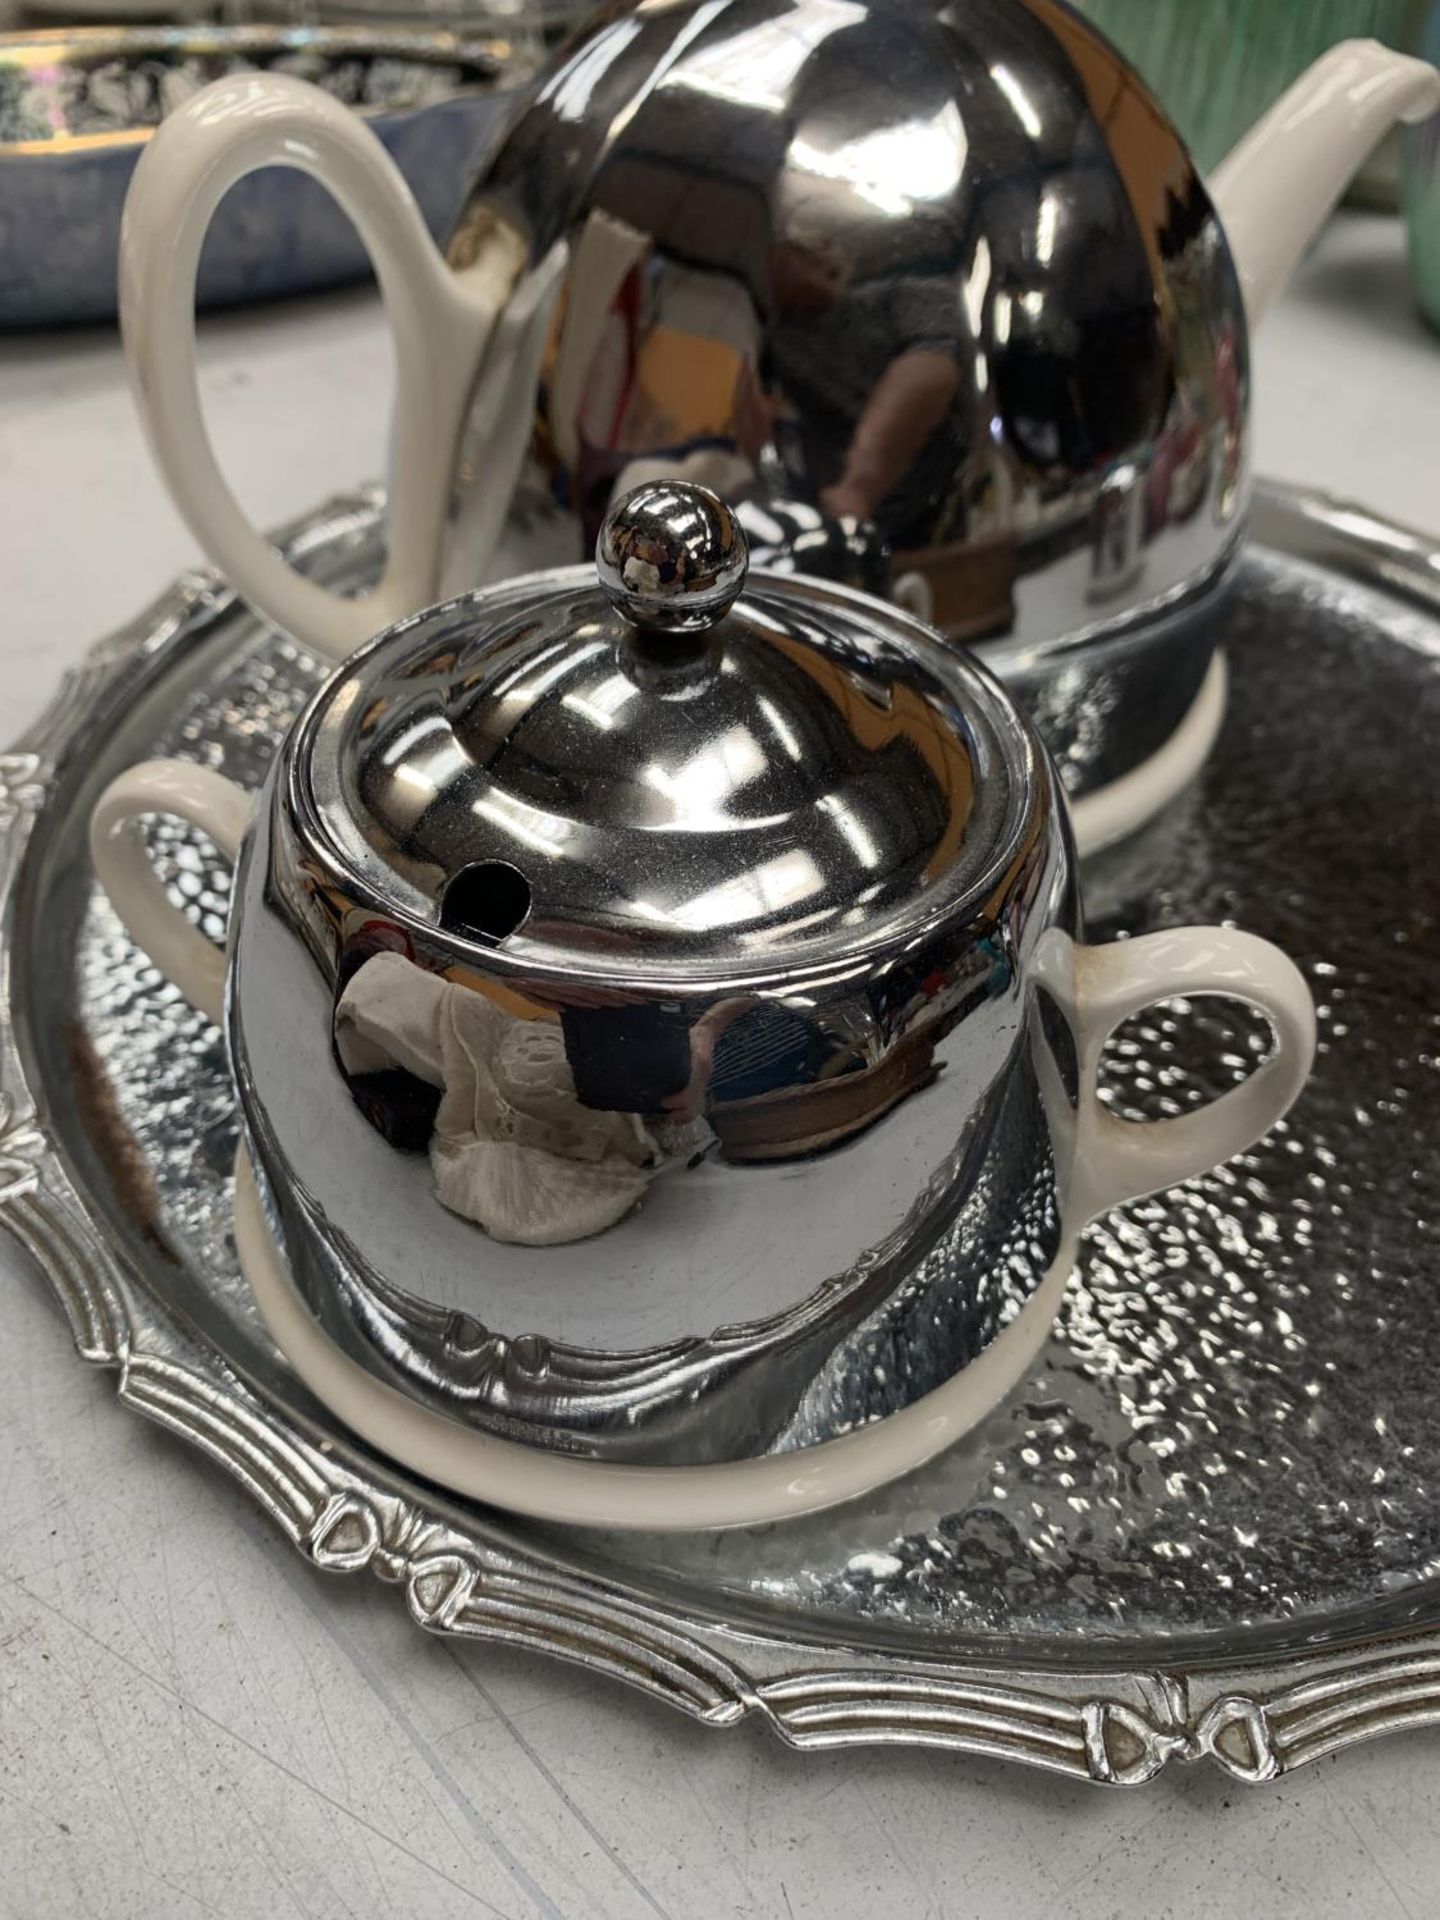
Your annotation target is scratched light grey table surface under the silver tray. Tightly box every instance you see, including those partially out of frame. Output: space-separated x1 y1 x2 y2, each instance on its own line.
0 215 1440 1920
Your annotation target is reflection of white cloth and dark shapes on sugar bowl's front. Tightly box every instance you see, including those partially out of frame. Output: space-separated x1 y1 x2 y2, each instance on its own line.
334 941 952 1205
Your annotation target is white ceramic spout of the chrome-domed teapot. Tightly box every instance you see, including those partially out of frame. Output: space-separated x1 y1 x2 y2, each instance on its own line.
1210 40 1440 326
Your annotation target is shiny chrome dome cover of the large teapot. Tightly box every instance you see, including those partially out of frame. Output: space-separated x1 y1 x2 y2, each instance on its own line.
449 0 1248 651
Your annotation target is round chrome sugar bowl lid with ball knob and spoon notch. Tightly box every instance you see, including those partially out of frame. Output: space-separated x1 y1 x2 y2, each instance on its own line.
288 482 1048 977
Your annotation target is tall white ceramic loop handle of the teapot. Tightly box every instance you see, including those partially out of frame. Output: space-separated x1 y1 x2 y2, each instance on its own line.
119 73 522 659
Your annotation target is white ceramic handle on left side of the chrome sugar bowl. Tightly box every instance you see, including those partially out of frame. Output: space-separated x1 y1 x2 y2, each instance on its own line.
90 760 255 1025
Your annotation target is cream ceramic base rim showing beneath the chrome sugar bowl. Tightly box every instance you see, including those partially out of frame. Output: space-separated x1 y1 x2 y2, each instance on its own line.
234 1146 1075 1532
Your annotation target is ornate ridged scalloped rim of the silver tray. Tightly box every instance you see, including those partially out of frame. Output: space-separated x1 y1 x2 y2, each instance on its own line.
0 488 1440 1786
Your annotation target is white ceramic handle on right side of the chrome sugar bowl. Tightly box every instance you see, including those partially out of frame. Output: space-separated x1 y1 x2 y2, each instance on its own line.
1071 927 1315 1221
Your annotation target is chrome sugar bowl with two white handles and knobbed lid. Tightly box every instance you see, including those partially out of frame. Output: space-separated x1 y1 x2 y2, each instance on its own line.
92 482 1313 1517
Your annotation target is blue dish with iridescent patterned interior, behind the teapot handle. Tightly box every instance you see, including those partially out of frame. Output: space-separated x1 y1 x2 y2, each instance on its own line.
0 27 534 326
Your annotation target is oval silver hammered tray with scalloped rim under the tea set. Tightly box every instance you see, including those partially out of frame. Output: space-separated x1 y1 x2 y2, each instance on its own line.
0 476 1440 1784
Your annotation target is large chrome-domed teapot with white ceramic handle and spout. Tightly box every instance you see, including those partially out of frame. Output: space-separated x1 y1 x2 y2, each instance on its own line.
123 0 1440 817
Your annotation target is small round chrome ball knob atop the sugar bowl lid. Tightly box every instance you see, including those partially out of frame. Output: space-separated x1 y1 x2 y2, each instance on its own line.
595 480 751 634
